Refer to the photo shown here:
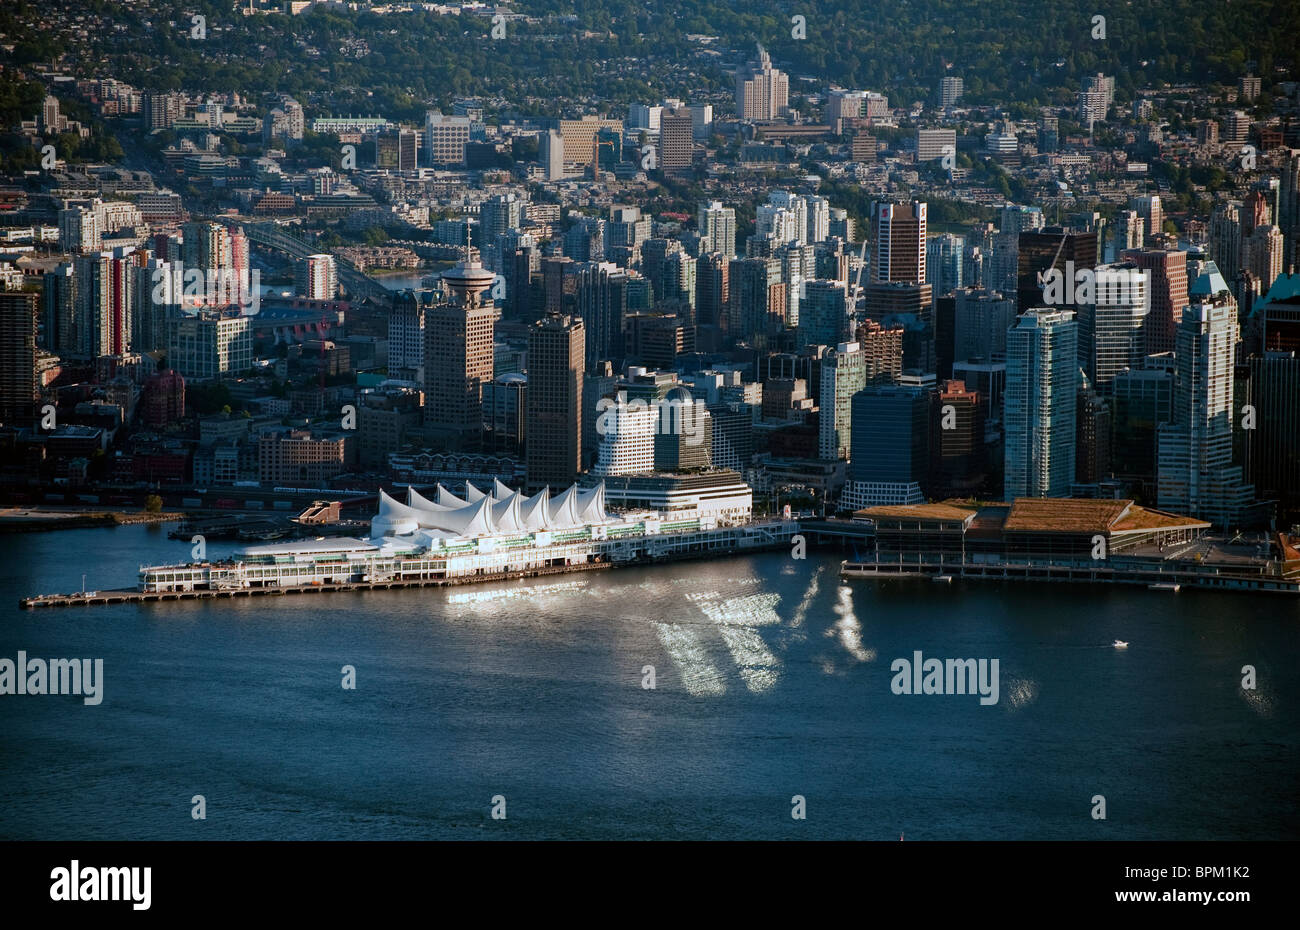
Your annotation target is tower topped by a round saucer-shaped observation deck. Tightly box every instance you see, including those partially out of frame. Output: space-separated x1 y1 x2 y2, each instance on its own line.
424 261 495 449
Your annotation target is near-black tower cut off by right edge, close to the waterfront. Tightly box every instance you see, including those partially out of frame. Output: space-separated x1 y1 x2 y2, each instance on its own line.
1242 351 1300 525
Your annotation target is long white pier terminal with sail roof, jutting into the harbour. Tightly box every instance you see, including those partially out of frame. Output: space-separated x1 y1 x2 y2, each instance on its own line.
139 481 774 593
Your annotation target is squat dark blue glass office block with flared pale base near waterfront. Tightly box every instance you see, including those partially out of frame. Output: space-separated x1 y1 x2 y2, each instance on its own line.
847 385 930 509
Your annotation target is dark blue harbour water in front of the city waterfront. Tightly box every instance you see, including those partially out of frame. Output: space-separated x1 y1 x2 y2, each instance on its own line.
0 525 1300 840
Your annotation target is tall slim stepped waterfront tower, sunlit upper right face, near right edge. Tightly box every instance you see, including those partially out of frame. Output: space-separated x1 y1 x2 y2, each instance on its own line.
1157 303 1255 527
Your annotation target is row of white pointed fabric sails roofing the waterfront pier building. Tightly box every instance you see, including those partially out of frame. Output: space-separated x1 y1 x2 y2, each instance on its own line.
371 481 610 538
